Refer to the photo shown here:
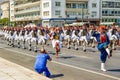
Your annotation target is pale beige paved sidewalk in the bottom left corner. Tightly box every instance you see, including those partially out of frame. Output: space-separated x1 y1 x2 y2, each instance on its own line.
0 57 51 80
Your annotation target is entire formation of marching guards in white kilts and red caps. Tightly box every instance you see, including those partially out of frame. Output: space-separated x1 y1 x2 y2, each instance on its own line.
0 25 120 52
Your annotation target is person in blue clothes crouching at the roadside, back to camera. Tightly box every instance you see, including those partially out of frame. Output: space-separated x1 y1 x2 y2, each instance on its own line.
34 48 52 77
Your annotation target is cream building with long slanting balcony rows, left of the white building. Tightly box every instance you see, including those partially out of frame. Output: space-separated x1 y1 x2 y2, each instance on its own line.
10 0 41 25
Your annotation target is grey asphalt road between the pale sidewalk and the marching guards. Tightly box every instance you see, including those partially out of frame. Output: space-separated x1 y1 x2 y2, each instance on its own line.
0 40 120 80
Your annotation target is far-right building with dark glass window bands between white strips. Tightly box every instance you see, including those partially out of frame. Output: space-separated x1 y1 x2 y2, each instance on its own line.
100 0 120 24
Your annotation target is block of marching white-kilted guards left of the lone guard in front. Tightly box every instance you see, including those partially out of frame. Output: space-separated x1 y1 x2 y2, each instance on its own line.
0 27 47 52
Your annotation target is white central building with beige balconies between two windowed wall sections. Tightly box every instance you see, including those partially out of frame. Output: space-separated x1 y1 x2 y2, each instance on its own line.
42 0 100 26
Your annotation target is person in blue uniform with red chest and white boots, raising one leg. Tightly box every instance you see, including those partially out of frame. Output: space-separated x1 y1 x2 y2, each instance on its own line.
92 26 110 71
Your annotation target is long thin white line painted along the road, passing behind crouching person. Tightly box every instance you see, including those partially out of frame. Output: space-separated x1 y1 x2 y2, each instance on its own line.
3 48 120 80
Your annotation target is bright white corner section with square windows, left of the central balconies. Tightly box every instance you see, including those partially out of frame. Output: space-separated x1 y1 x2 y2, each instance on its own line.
41 0 66 26
